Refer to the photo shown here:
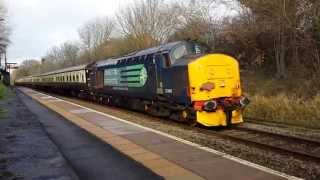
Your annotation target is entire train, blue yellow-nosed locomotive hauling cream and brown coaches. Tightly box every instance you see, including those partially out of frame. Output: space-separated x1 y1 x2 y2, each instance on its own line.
15 41 249 127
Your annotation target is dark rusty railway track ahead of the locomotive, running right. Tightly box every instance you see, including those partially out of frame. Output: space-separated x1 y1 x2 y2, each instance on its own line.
199 126 320 163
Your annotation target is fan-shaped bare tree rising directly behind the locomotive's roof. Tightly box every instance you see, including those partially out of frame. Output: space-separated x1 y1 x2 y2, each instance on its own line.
117 0 180 49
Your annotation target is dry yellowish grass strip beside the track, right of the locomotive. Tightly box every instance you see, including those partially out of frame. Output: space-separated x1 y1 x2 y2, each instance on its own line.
245 94 320 128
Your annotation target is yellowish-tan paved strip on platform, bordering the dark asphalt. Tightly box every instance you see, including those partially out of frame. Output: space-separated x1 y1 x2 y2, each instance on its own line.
22 89 204 180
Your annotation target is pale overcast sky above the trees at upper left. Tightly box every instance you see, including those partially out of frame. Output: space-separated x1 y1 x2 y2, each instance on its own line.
5 0 132 62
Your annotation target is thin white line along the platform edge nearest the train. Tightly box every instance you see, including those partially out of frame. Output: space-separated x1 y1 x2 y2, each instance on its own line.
25 88 302 180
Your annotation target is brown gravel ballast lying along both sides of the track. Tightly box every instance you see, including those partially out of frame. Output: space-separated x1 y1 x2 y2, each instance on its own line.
60 97 320 180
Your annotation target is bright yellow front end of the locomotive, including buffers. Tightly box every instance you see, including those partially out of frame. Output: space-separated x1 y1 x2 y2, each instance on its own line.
188 54 249 127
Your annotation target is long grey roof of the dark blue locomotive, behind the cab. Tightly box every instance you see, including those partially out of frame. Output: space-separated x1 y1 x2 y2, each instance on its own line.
96 41 185 67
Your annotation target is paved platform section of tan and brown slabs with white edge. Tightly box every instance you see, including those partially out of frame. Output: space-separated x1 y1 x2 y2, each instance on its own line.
19 87 298 180
